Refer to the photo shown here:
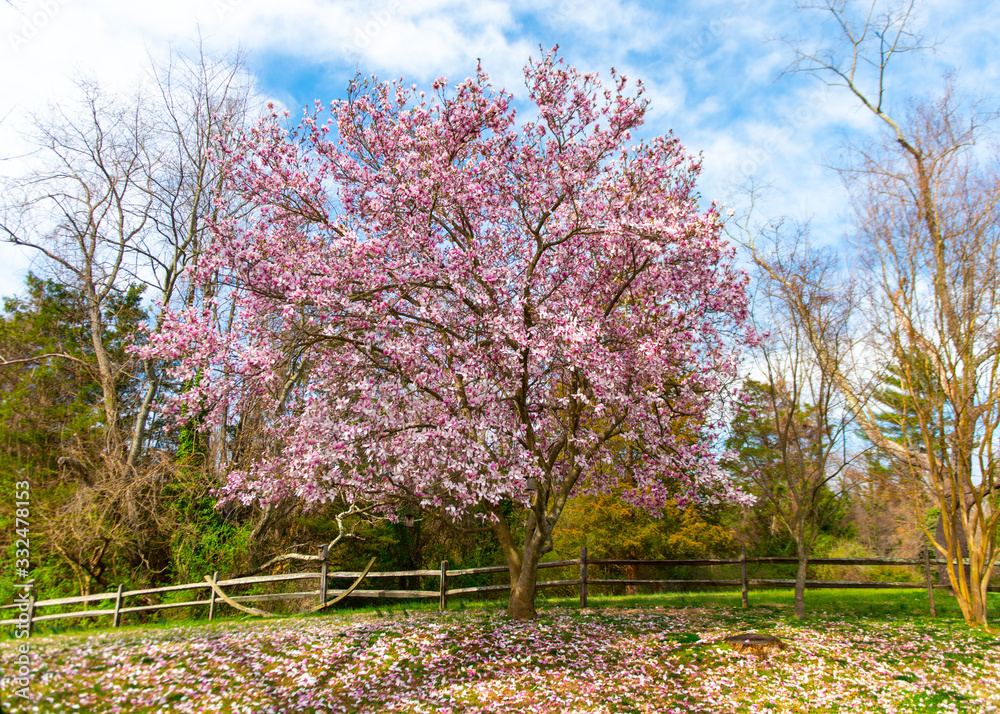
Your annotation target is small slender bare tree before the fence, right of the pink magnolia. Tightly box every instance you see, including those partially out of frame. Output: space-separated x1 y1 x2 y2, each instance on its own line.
729 224 854 617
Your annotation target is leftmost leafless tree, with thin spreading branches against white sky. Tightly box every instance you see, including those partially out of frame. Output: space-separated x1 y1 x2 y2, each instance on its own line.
0 83 155 452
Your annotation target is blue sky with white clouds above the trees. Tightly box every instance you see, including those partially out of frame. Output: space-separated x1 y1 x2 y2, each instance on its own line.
0 0 1000 295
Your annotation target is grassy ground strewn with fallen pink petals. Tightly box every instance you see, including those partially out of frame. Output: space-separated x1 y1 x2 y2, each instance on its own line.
0 609 1000 714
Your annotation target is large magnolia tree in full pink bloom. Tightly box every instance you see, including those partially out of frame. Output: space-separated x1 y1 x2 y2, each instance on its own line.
147 53 752 618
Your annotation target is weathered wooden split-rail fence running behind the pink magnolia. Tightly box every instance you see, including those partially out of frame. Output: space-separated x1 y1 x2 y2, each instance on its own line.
0 547 1000 631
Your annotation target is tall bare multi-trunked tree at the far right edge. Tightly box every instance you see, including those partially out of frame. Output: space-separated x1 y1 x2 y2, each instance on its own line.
780 0 1000 626
